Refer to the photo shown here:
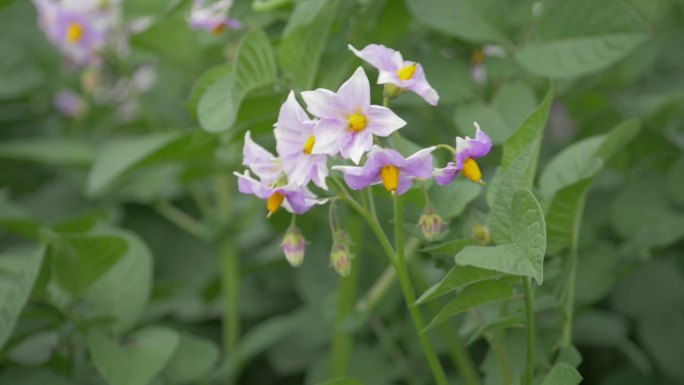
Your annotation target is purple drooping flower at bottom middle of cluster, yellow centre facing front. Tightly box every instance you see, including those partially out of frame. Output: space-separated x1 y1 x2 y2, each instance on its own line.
333 146 435 195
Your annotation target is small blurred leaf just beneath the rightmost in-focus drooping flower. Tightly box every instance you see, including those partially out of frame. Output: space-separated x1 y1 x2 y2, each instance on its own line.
428 182 482 221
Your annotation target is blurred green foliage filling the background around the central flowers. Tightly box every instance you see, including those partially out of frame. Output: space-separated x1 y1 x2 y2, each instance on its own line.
0 0 684 385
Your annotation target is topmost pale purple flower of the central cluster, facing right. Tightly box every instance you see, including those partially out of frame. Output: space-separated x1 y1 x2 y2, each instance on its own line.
347 44 439 106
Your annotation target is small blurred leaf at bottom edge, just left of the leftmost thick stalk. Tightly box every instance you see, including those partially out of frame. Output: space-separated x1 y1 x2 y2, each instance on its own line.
162 333 219 385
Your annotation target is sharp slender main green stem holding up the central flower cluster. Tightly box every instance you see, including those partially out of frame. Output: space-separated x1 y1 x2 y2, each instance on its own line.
392 195 448 385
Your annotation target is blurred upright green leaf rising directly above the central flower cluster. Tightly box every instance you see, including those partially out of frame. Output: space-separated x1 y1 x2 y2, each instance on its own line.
278 0 338 90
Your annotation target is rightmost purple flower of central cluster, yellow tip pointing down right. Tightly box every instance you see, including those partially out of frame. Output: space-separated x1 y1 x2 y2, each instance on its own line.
435 123 492 186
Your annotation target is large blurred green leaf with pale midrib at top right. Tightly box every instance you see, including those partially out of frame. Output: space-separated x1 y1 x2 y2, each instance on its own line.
516 0 649 78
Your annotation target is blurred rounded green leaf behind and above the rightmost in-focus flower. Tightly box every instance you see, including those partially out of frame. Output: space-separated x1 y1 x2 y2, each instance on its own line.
454 81 537 144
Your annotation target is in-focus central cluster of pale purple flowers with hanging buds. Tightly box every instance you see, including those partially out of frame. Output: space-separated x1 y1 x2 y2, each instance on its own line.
235 45 492 275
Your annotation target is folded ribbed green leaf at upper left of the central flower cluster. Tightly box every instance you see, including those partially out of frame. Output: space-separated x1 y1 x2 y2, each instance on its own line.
197 29 276 133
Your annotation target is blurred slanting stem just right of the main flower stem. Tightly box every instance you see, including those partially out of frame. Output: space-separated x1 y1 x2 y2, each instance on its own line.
411 264 482 385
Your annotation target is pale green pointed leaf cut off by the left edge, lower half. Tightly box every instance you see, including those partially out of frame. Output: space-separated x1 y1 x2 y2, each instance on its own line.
0 247 45 349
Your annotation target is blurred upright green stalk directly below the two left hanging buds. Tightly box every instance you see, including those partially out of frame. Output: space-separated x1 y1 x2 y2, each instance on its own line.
330 217 362 378
